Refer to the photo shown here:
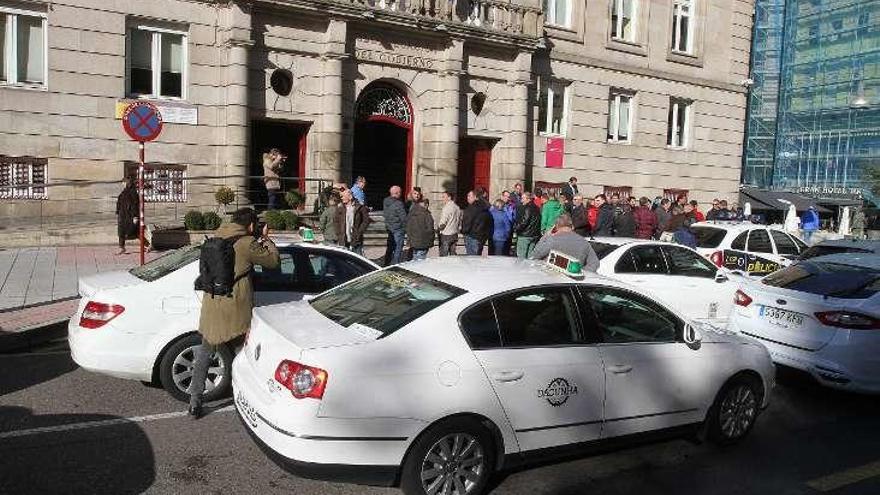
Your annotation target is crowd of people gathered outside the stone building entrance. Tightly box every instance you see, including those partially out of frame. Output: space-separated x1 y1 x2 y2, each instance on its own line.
319 177 743 265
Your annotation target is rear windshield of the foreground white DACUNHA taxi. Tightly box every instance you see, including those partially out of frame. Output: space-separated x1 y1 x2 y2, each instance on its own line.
310 267 466 337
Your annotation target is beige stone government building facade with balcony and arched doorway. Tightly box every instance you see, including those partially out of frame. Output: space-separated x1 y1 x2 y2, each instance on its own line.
0 0 752 231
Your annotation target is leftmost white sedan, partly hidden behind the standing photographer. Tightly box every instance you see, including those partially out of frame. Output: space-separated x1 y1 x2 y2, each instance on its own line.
68 240 379 401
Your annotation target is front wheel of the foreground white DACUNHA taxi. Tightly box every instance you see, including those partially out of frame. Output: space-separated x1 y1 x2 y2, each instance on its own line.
706 376 763 446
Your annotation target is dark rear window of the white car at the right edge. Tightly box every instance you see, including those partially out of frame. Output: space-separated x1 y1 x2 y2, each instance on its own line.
763 261 880 299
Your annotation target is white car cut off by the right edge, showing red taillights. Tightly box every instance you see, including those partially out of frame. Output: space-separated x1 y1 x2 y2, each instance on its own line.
729 253 880 393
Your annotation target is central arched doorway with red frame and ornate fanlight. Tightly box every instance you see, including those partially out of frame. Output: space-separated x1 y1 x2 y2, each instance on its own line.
352 83 413 210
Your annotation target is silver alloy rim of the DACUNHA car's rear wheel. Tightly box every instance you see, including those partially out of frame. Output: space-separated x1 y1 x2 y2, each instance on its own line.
420 433 487 495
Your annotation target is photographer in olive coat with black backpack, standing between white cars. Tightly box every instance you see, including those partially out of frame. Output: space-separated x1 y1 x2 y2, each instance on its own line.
189 208 280 419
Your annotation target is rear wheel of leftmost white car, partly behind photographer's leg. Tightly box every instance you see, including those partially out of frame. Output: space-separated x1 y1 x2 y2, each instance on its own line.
159 333 235 402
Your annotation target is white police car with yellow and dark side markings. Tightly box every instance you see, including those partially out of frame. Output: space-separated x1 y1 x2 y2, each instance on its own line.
691 221 807 277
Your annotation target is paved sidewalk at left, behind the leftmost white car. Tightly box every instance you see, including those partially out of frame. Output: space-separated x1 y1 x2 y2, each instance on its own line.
0 246 162 337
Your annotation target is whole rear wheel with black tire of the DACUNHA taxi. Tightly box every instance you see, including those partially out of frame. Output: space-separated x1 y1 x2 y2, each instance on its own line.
400 418 495 495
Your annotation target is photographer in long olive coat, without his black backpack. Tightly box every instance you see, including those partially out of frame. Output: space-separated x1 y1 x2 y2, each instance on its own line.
189 208 280 419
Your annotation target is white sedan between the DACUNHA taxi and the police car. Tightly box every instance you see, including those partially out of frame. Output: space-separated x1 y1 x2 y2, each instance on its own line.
590 237 745 325
